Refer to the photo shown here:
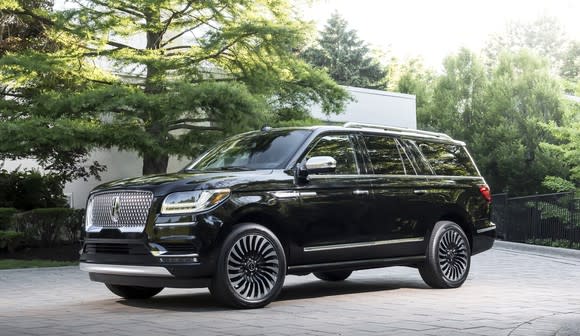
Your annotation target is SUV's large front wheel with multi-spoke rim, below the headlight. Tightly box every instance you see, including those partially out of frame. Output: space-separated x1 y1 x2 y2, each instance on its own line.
210 223 286 308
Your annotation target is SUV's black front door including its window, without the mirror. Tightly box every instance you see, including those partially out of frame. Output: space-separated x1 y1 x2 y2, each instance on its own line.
296 134 371 263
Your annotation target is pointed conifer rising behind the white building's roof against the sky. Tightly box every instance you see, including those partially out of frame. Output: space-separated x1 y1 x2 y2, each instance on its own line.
302 13 387 89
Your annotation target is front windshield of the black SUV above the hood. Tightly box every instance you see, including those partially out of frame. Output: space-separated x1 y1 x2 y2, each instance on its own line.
185 129 311 170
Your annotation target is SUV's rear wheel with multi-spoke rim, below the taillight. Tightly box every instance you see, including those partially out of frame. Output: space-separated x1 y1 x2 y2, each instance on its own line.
419 221 471 288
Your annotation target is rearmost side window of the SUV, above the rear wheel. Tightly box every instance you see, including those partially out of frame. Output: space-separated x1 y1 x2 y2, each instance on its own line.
417 141 478 176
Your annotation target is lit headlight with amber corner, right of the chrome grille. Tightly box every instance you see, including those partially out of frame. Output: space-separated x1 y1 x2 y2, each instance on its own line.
161 189 230 215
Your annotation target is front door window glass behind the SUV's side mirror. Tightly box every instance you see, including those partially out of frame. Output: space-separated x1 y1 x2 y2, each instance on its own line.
306 134 358 175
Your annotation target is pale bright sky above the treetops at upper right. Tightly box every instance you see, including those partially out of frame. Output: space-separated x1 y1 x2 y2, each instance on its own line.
298 0 580 68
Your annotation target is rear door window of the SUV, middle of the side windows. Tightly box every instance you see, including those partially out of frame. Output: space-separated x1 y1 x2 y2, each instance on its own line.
363 135 414 175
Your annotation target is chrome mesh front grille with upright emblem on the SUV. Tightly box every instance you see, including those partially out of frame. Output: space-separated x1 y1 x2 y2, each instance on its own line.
87 191 153 232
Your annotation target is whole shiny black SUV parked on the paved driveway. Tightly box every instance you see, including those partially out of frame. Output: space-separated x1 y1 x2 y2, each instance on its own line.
80 123 495 308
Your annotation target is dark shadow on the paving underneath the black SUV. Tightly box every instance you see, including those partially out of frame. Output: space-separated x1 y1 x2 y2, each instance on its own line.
117 280 428 312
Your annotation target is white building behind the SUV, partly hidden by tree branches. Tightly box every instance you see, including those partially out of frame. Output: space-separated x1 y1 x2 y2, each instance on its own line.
0 87 417 208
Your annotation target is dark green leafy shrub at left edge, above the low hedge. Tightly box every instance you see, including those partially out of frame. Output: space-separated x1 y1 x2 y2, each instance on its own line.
0 170 66 210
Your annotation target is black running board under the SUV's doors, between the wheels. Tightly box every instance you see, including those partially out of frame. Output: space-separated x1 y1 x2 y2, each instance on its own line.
288 255 425 275
